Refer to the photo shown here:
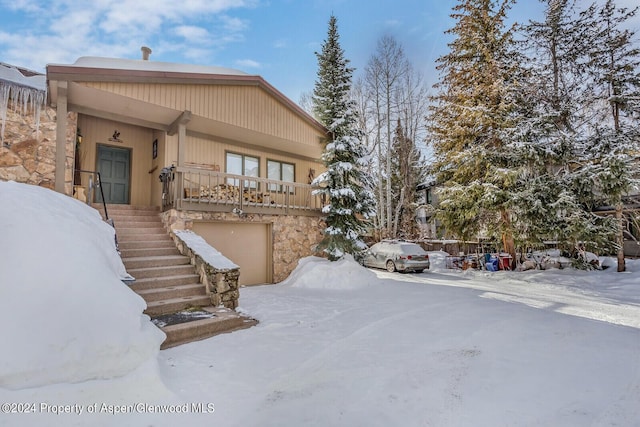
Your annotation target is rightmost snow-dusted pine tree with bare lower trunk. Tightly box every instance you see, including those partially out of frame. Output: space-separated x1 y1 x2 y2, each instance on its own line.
580 0 640 271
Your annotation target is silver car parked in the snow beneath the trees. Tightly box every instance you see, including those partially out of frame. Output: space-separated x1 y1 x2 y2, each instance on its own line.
358 240 430 273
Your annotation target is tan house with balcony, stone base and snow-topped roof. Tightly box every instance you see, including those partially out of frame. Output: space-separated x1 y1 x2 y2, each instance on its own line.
0 48 327 285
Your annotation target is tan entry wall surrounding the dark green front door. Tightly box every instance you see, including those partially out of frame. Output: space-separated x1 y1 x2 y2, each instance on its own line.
78 114 153 206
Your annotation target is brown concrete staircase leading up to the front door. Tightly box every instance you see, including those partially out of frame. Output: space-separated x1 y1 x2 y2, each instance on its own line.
96 205 257 349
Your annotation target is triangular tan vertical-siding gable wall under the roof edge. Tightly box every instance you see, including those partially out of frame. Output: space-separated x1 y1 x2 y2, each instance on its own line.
82 82 318 148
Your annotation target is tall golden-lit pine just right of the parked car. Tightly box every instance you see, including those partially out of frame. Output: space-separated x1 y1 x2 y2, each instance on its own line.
430 0 522 260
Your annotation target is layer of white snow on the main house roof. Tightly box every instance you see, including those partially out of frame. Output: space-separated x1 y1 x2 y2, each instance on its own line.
52 56 249 76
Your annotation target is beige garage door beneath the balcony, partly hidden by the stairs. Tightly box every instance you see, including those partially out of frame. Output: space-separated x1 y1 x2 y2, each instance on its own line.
193 222 272 286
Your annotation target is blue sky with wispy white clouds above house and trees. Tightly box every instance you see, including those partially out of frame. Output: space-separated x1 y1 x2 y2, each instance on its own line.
0 0 637 102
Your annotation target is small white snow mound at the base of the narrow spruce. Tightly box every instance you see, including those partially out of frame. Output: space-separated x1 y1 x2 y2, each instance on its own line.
281 255 378 290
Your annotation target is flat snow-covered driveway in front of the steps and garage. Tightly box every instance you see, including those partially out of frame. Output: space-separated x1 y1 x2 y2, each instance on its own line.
161 263 640 426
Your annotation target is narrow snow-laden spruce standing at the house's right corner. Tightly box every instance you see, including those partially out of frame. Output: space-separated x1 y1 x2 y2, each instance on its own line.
313 15 375 261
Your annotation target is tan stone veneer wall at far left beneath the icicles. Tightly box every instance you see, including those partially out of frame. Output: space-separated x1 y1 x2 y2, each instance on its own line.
0 102 78 195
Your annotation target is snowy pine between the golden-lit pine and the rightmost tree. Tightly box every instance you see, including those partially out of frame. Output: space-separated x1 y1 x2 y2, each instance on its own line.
513 0 612 251
